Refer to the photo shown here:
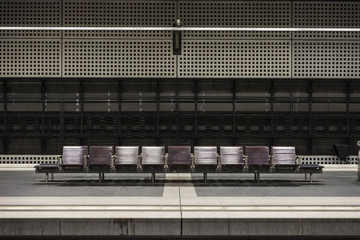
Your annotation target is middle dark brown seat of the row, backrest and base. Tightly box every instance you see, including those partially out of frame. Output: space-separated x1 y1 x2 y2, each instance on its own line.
165 146 193 172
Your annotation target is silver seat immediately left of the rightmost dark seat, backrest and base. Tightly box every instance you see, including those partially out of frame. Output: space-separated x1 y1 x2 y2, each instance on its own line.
220 146 245 172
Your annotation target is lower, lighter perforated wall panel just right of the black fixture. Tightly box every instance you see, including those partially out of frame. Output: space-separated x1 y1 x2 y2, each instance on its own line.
179 40 291 78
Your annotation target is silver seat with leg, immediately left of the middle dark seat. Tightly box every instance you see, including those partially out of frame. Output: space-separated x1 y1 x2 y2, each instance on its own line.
140 146 165 182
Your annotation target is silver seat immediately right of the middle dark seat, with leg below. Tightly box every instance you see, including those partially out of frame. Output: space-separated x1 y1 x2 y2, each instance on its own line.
193 146 220 182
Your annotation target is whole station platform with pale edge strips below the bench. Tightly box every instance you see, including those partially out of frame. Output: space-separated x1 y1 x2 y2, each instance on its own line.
0 166 360 239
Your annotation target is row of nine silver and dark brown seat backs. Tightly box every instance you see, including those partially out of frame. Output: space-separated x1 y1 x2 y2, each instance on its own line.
59 146 298 168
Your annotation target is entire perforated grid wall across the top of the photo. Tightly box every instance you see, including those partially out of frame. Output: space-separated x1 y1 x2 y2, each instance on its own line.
0 0 360 78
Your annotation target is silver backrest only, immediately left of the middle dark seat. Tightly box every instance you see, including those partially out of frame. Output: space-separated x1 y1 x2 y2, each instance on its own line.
141 146 165 165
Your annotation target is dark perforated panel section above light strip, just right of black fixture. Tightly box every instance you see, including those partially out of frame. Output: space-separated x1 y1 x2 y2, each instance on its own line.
179 1 291 27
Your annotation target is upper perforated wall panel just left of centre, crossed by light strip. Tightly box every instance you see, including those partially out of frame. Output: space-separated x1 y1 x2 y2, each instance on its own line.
63 0 176 39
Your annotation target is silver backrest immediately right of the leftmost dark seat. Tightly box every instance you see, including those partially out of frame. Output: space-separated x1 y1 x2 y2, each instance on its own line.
114 146 139 165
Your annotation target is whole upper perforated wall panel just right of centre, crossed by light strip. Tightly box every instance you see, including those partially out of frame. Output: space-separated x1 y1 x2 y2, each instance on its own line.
179 1 291 39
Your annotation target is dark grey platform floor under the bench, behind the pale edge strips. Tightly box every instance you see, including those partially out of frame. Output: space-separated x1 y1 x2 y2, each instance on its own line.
0 171 360 197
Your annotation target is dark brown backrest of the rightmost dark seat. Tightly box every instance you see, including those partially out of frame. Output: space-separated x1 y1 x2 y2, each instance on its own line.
245 146 270 165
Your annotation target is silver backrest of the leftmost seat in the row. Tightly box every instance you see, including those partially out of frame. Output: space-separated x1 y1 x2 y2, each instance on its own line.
62 146 88 165
